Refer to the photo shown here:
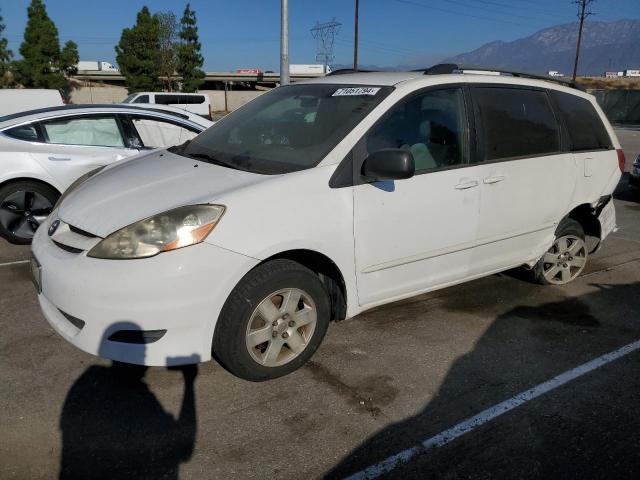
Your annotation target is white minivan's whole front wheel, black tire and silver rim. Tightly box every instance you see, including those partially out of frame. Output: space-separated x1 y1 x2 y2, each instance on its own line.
213 259 330 382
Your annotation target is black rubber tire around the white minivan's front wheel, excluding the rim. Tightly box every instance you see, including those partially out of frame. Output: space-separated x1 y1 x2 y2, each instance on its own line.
212 259 330 382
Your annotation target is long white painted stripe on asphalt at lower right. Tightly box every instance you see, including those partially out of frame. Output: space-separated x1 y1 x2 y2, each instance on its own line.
347 340 640 480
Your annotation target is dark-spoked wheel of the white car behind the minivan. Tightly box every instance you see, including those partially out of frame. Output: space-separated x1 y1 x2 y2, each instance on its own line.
0 180 60 245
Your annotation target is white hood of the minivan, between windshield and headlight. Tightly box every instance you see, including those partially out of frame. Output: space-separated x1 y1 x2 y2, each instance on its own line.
58 150 269 237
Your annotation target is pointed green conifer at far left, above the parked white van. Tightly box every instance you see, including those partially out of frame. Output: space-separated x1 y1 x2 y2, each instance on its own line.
13 0 71 89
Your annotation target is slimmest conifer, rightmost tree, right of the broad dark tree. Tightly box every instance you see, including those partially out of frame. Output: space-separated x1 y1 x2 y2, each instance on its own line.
177 3 204 92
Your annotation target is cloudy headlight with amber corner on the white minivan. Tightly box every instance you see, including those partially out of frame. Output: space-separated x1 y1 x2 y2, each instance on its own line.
87 205 225 259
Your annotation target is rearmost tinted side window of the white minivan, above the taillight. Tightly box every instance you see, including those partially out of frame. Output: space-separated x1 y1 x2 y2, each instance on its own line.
551 91 612 151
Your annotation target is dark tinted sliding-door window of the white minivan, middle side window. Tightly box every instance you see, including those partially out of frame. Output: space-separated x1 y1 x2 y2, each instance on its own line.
473 87 560 160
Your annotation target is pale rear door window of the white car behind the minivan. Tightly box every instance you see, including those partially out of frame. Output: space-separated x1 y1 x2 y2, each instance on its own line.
42 117 124 147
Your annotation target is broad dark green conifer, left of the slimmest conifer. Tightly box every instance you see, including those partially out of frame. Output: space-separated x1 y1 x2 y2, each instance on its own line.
116 6 162 93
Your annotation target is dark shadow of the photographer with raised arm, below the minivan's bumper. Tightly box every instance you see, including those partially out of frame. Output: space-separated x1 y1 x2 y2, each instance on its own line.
60 322 198 480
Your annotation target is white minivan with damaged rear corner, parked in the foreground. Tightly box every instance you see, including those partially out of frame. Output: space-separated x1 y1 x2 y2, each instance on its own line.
32 67 624 381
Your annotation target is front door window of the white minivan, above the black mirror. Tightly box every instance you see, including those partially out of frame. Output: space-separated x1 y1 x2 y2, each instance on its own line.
366 88 467 172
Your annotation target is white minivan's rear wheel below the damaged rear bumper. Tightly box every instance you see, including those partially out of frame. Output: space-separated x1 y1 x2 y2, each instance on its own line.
534 218 588 285
